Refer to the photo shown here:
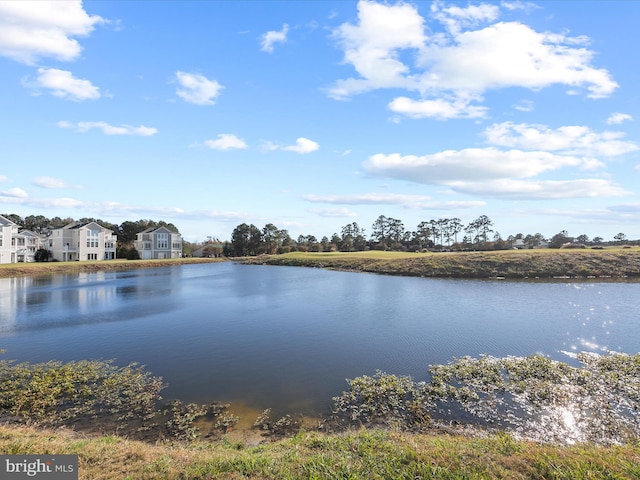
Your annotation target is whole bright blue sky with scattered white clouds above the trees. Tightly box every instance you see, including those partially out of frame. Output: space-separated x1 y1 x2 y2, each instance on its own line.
0 0 640 241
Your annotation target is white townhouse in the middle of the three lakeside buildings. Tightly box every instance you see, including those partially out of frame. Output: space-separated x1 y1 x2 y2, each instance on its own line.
46 222 117 262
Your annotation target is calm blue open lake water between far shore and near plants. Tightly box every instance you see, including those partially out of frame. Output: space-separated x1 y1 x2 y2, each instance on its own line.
0 263 640 415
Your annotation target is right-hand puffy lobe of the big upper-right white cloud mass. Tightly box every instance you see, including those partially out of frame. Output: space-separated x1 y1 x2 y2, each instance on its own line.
420 22 618 98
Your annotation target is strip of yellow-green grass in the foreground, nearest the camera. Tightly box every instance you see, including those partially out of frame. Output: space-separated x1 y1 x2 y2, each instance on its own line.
0 426 640 480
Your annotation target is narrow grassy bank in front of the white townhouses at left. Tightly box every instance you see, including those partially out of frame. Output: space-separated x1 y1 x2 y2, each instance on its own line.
0 258 226 278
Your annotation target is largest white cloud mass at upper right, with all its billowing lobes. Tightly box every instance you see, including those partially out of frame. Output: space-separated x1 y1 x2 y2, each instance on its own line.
328 0 618 119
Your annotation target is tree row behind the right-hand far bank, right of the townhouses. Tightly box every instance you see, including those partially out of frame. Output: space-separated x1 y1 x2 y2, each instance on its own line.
229 215 639 256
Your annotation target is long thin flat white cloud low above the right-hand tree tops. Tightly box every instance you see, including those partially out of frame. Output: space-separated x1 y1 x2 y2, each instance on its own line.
302 193 485 210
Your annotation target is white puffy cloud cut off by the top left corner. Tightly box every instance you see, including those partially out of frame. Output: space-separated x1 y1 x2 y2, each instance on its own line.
0 0 105 65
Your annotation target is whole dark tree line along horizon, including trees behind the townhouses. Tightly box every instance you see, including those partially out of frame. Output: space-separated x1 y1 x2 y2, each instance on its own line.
2 213 640 258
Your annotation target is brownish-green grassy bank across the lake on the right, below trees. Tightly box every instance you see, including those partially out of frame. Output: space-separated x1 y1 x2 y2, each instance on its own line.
243 247 640 278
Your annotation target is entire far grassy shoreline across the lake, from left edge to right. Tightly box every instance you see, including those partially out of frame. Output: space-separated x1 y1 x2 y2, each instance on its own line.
0 247 640 281
